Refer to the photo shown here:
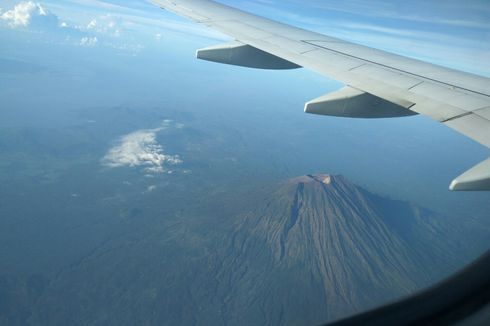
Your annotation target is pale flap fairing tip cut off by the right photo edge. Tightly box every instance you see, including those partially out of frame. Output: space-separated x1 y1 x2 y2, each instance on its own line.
449 158 490 191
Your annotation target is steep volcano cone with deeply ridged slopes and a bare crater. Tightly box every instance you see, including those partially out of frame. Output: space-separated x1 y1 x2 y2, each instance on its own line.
212 175 453 325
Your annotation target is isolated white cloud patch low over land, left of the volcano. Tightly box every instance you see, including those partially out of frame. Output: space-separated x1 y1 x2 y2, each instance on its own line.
102 120 182 173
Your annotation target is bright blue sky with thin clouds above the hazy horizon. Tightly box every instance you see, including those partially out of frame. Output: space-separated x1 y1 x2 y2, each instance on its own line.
0 0 490 76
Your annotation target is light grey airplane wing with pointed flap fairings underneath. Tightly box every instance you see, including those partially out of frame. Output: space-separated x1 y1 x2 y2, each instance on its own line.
153 0 490 190
